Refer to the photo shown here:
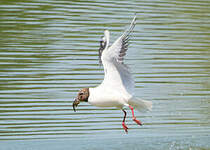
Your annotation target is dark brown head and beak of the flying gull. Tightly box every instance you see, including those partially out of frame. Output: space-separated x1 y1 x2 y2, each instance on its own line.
72 88 89 112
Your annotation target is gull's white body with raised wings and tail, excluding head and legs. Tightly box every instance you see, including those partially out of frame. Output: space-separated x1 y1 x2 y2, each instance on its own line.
88 17 152 111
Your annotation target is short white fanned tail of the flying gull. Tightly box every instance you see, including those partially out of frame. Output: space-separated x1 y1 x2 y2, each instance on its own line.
128 97 152 112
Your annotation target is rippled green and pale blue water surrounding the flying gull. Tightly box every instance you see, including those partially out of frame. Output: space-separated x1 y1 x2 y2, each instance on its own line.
0 0 210 149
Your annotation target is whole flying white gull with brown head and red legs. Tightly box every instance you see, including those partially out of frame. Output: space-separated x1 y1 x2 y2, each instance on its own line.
73 15 152 133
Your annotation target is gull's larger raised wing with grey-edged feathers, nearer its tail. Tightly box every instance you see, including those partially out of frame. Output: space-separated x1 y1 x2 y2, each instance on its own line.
101 16 136 94
